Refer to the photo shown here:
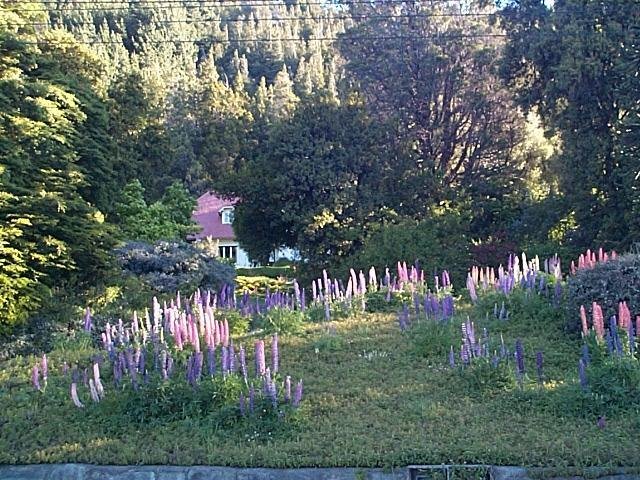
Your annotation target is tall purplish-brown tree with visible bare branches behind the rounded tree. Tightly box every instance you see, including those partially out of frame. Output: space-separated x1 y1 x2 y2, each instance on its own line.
338 1 526 209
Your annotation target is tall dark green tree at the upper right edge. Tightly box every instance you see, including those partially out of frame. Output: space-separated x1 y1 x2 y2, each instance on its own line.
502 0 638 249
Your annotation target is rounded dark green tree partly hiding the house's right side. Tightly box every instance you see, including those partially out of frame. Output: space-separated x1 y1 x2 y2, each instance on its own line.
221 102 390 266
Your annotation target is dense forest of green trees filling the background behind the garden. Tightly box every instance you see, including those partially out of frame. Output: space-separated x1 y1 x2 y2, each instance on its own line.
0 0 640 325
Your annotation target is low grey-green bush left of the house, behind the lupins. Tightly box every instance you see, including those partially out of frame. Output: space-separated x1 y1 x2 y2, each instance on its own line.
116 242 235 292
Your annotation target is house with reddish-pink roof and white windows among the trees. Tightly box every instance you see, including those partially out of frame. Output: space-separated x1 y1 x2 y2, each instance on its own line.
192 192 251 267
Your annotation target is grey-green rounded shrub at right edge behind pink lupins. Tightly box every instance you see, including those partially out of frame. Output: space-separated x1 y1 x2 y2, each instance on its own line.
566 254 640 332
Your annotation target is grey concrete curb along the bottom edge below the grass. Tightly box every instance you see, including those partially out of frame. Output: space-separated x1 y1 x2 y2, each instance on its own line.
0 463 640 480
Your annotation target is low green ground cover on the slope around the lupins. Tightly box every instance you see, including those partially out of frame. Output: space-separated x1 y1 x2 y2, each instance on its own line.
0 286 640 467
